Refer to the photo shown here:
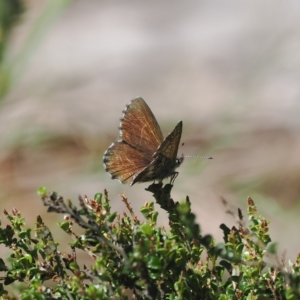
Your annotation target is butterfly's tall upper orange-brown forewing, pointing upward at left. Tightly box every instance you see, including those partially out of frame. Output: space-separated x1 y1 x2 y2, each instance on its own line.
121 98 163 157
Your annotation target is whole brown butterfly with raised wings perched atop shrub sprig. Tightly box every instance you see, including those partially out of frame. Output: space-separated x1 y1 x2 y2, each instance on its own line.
103 98 183 185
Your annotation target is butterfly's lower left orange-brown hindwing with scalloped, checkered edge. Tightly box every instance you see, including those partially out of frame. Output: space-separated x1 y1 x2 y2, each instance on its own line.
103 141 152 183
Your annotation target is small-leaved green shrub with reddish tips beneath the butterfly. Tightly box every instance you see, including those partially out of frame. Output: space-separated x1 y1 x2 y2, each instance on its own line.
0 184 300 300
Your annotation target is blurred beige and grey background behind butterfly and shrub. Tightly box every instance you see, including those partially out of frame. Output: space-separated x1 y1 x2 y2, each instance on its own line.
0 0 300 260
